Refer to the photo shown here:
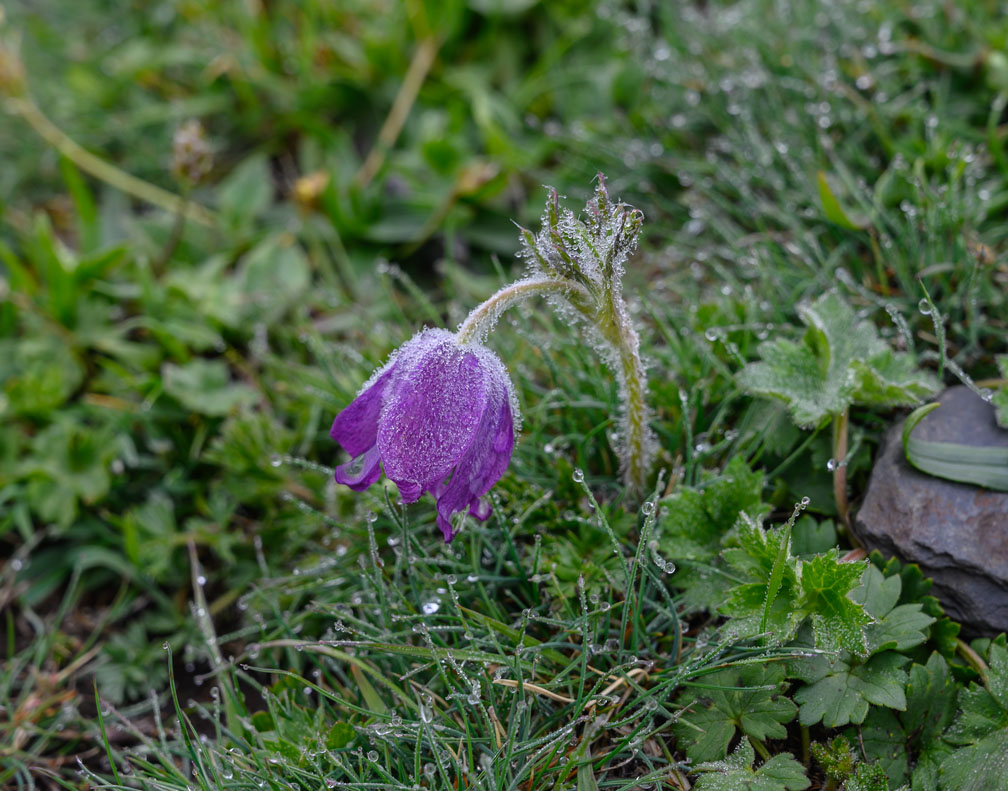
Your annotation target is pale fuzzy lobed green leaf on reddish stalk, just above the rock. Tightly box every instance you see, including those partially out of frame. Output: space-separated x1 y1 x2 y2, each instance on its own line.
738 293 938 426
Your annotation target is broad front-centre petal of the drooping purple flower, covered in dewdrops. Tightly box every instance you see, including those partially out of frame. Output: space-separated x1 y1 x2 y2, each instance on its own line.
377 329 488 493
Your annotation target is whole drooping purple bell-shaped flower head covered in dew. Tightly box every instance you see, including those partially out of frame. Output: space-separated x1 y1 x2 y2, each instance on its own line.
330 329 518 542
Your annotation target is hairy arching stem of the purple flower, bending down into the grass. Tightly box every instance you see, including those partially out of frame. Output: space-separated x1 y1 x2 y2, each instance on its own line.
458 277 651 494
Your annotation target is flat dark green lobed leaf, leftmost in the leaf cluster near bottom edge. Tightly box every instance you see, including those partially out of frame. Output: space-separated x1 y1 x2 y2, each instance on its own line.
672 664 797 761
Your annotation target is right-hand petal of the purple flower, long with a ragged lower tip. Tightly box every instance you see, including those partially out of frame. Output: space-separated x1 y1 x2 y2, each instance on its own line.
437 356 514 542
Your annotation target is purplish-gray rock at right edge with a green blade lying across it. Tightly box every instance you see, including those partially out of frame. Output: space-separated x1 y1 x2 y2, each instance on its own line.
854 387 1008 635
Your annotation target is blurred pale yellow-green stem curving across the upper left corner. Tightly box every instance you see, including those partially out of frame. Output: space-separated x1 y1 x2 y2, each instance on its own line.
5 97 217 226
